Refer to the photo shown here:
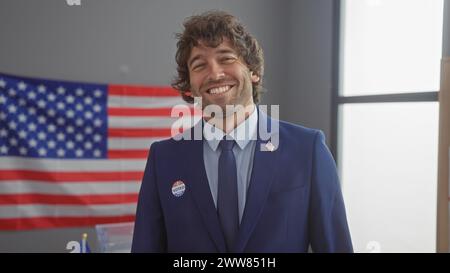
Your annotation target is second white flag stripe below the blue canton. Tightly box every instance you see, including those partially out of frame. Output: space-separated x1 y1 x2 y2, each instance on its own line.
0 180 141 195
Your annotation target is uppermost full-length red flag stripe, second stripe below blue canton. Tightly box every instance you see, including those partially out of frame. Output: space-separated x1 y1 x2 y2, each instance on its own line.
0 170 143 183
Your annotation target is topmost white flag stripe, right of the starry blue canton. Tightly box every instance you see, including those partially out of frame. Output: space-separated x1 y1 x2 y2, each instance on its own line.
108 95 189 108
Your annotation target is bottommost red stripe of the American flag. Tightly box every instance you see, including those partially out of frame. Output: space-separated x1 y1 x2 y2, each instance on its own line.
0 214 135 230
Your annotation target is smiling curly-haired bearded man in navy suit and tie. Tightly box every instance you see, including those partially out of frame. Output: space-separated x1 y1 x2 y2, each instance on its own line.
132 11 352 252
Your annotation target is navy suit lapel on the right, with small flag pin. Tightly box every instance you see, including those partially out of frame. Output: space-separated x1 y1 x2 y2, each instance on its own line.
234 109 280 252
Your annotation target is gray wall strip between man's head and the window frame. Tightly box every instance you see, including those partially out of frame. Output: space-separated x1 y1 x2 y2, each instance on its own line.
280 0 333 139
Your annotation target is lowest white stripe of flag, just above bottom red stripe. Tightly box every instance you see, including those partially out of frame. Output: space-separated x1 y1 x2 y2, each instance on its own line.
0 204 136 219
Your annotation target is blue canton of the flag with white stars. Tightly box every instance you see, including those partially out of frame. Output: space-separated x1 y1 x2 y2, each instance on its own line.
0 75 108 159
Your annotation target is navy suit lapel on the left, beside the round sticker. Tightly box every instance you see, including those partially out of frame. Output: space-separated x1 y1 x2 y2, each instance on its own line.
186 122 226 252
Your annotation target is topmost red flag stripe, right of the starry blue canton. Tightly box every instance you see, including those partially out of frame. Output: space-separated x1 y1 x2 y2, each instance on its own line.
108 85 180 97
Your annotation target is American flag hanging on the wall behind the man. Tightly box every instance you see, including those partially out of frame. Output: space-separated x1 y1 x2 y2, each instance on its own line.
0 74 193 230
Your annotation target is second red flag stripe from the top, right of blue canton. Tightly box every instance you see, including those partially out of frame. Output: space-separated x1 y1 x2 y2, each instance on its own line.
108 107 201 118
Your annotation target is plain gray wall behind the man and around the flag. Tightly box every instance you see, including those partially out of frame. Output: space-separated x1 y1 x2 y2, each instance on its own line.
0 0 332 252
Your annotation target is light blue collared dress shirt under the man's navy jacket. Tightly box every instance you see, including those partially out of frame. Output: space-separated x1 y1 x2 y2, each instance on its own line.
203 107 258 221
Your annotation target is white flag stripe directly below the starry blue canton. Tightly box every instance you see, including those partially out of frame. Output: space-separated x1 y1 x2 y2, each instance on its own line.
0 156 147 172
